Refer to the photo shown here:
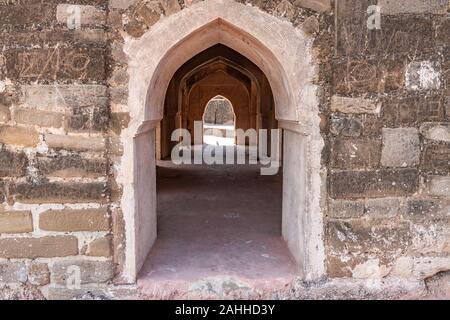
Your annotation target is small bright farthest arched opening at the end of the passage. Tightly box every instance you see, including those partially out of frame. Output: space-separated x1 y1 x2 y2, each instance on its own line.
203 96 236 147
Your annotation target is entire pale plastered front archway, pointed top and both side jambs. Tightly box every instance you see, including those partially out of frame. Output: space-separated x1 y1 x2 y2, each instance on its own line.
119 0 324 282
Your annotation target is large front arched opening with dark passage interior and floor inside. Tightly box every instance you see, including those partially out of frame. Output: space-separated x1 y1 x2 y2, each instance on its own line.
139 45 300 291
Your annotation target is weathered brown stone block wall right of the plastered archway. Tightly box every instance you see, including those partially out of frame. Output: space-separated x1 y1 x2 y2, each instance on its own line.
326 0 450 279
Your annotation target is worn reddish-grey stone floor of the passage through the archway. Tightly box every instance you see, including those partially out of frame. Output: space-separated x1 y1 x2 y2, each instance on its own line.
138 161 298 298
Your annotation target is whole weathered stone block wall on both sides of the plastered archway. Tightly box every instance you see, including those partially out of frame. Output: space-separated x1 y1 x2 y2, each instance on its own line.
0 0 450 298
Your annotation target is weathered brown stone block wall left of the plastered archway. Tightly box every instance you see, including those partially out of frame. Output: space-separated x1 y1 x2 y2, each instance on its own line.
0 0 115 297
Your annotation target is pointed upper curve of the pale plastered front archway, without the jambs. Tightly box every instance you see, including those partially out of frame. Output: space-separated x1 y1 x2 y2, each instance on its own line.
126 0 315 131
